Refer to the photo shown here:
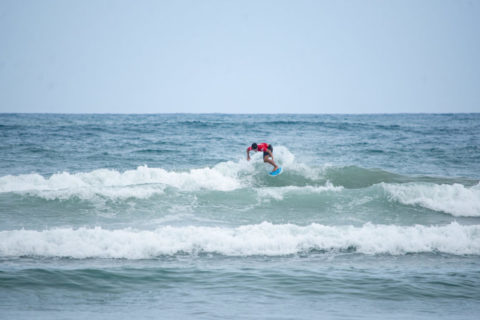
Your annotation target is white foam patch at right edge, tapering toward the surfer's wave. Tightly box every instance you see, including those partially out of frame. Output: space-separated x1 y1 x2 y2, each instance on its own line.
382 183 480 217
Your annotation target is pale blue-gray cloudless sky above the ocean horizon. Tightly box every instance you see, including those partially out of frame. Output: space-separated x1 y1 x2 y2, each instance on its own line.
0 0 480 113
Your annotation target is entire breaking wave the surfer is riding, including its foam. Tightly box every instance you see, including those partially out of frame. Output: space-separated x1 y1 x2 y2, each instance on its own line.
0 146 480 217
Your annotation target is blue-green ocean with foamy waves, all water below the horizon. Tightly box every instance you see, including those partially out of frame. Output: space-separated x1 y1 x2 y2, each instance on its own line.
0 114 480 320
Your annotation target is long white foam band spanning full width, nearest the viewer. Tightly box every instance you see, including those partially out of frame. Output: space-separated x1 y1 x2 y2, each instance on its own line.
0 222 480 259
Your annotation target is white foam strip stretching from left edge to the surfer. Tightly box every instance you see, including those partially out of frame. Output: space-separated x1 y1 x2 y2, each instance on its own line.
0 163 246 199
